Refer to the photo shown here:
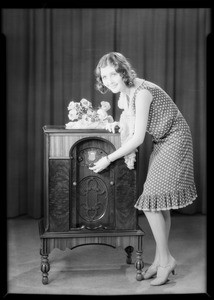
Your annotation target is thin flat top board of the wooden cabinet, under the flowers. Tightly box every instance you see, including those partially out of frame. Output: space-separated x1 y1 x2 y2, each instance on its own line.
43 125 117 134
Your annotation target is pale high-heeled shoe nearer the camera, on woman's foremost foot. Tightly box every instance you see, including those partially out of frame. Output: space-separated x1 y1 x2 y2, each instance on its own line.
150 259 177 285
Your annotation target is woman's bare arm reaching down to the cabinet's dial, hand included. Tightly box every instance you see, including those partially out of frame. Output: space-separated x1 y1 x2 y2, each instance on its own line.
90 89 152 173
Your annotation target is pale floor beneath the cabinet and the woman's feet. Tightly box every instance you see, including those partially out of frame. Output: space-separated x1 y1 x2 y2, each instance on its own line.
7 214 206 295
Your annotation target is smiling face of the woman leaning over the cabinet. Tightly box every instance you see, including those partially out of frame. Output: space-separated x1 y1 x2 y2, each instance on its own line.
100 65 127 93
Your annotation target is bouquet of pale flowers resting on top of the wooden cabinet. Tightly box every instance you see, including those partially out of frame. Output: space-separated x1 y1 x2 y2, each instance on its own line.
65 98 114 129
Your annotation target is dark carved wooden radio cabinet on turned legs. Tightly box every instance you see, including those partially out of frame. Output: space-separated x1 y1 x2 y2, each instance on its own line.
39 126 144 284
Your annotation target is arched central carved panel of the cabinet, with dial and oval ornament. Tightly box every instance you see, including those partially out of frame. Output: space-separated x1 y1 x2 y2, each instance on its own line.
70 138 115 229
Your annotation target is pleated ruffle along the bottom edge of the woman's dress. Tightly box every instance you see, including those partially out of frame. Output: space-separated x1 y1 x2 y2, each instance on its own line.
134 184 197 211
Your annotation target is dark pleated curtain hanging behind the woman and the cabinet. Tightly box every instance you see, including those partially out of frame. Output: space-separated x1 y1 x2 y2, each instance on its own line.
2 8 210 218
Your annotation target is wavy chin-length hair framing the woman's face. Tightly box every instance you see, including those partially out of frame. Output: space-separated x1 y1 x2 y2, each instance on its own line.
95 52 137 94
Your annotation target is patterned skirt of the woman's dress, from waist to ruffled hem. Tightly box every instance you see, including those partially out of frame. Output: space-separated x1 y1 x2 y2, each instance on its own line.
135 118 197 211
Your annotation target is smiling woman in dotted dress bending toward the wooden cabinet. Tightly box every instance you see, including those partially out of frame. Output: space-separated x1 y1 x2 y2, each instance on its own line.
90 52 197 285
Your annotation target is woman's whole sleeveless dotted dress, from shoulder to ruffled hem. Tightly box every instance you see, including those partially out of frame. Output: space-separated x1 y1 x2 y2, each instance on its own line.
131 80 197 211
